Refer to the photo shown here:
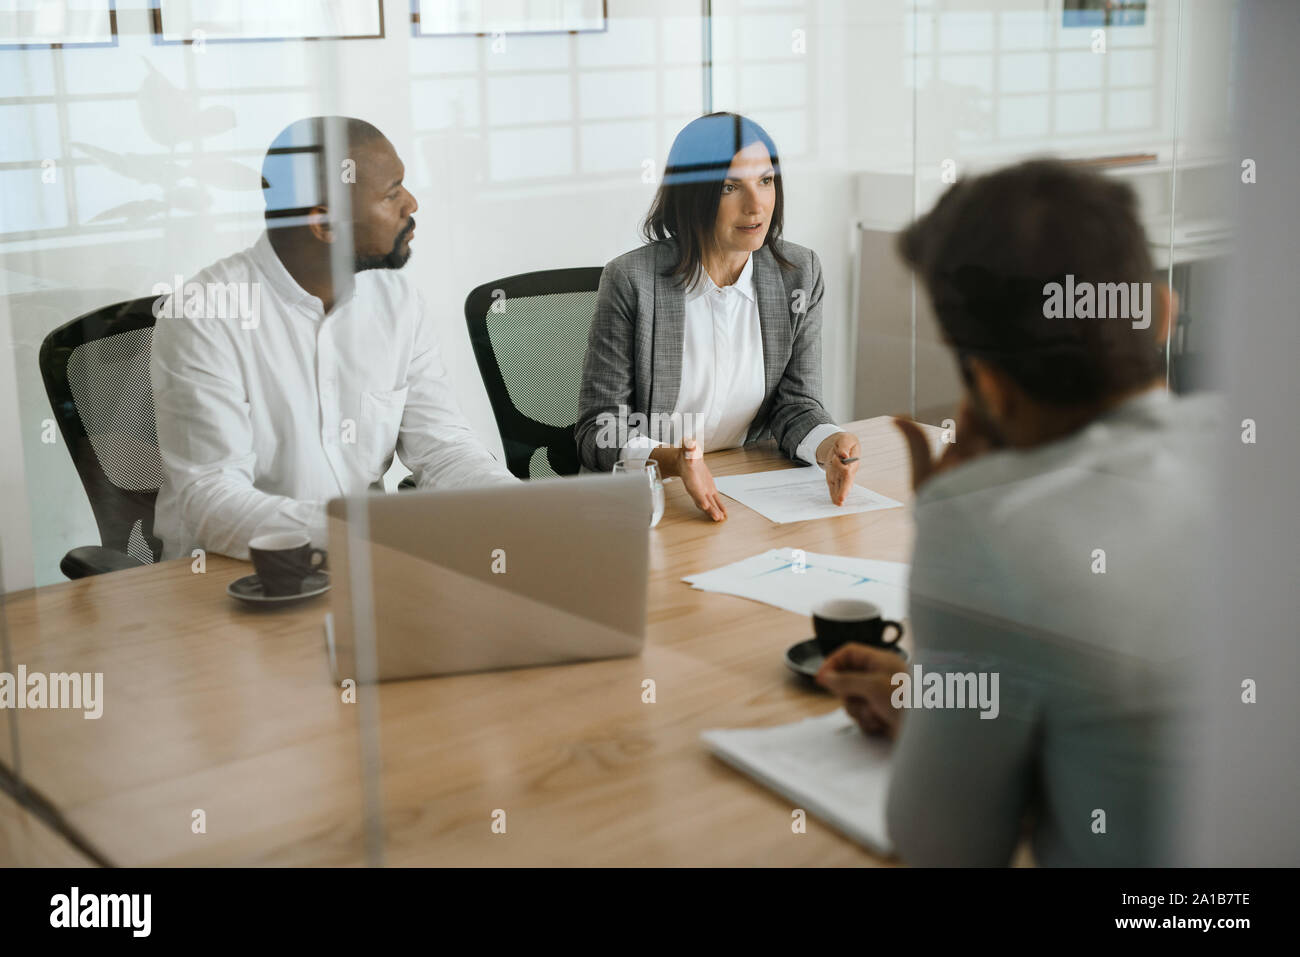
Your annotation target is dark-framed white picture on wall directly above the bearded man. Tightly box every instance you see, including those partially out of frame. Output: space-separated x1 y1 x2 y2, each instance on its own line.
150 0 384 43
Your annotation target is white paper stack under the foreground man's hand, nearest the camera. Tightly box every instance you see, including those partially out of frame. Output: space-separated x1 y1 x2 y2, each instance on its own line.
699 707 893 854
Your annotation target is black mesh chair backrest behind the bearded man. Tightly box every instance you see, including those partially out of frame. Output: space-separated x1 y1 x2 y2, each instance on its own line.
40 296 163 563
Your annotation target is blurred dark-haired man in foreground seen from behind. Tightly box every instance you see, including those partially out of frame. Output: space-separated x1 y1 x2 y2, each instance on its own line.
819 161 1211 866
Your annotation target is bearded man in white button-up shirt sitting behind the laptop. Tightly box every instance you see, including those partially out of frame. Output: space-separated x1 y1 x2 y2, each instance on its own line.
150 117 517 558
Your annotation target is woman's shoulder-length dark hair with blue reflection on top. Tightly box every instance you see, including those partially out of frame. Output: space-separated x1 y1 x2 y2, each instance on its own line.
641 113 793 286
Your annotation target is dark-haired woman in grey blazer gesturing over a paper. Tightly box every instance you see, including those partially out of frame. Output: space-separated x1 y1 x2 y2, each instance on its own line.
576 113 859 521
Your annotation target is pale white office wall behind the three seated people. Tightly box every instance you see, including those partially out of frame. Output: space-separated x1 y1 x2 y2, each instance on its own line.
0 0 1240 588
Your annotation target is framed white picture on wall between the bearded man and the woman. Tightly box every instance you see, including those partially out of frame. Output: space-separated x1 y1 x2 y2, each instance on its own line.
411 0 608 36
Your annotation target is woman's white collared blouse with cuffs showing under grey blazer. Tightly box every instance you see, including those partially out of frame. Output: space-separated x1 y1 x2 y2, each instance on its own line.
623 256 840 464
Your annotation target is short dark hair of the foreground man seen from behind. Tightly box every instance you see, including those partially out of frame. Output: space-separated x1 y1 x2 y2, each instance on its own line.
898 160 1164 406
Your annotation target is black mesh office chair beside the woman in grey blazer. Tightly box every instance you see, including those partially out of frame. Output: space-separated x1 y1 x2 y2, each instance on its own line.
465 267 602 479
